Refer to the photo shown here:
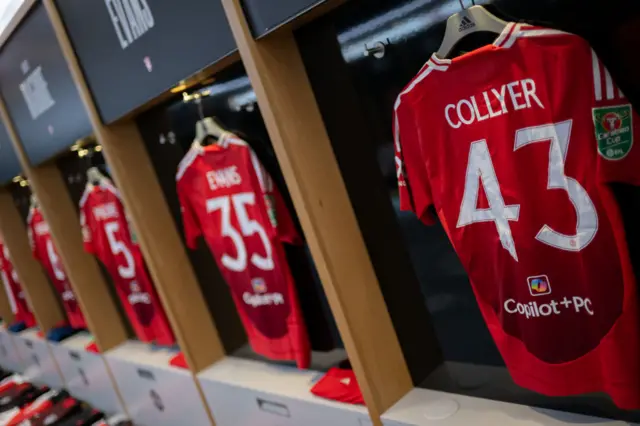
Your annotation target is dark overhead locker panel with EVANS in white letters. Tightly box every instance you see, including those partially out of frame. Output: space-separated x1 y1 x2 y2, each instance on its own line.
57 0 236 123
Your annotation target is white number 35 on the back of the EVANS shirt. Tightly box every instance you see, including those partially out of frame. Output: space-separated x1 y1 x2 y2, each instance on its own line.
207 192 274 272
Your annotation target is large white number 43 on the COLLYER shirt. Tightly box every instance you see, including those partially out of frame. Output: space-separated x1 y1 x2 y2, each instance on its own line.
457 120 598 261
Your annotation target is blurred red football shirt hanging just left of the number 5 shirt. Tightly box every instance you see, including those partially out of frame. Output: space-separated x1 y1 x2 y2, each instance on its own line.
27 207 87 328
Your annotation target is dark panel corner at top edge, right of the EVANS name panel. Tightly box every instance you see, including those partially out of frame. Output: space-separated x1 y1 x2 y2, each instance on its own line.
242 0 327 37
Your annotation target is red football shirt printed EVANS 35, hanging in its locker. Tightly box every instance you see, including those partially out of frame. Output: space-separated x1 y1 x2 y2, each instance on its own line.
177 134 310 368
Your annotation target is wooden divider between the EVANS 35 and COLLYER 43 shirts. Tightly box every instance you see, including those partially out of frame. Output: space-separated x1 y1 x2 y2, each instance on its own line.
222 0 413 425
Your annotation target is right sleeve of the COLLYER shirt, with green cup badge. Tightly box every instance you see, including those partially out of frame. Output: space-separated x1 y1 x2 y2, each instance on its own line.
591 50 640 185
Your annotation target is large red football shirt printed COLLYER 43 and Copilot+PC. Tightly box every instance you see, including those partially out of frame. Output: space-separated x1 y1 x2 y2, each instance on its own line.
395 24 640 409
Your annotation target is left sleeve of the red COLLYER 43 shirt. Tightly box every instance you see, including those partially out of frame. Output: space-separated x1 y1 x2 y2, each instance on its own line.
393 94 435 225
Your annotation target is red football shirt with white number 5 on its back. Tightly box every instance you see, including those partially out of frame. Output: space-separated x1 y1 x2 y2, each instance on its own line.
80 179 175 345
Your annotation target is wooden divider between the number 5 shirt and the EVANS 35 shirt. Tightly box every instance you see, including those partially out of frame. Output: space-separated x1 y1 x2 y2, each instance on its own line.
44 0 224 373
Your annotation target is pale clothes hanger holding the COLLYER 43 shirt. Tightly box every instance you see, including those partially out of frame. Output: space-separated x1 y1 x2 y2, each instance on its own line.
436 0 508 59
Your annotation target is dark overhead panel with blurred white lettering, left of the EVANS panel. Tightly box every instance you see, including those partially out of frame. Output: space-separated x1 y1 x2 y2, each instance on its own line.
0 4 92 165
